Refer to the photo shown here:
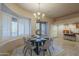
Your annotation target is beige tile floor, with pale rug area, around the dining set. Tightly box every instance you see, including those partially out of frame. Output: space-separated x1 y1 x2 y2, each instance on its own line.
12 38 79 56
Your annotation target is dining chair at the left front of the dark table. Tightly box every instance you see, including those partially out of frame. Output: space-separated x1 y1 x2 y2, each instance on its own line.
23 37 35 56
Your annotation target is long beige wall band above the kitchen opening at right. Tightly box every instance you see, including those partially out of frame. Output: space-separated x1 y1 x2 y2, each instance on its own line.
54 13 79 24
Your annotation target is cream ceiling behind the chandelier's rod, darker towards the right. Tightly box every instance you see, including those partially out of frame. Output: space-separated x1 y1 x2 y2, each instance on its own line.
19 3 79 18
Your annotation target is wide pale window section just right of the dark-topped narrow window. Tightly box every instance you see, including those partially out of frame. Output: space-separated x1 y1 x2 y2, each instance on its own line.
19 19 31 35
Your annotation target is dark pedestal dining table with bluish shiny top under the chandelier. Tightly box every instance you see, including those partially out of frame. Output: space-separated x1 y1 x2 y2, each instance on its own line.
30 37 47 55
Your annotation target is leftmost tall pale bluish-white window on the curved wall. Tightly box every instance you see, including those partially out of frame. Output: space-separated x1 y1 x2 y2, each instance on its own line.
2 14 10 38
